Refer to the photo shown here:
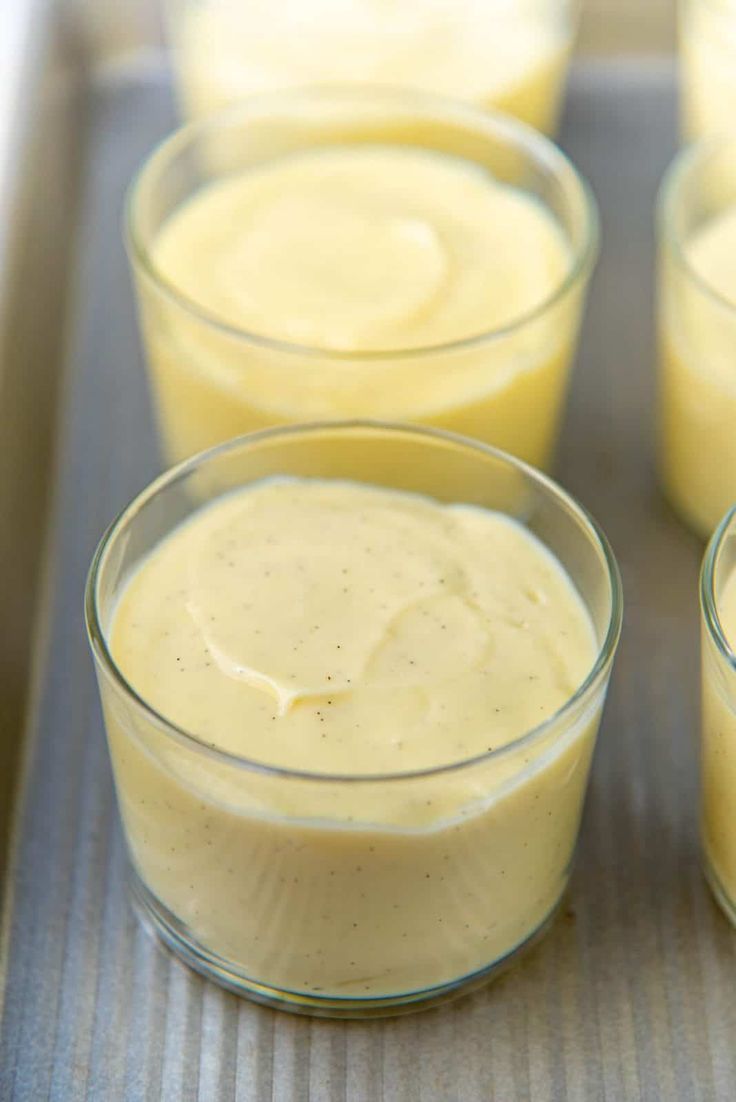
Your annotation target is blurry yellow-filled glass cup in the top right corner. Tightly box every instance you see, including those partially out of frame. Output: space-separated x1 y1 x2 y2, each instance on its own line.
678 0 736 141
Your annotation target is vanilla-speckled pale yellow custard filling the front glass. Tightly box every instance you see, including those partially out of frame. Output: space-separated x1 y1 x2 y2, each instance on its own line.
104 478 602 998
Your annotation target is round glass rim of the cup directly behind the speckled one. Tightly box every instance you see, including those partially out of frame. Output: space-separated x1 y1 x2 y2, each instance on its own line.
123 84 600 363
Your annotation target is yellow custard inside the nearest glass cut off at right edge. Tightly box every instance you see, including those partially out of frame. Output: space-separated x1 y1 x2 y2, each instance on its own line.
701 559 736 918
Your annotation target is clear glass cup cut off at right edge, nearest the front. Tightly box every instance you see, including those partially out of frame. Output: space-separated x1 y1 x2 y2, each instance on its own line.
700 508 736 925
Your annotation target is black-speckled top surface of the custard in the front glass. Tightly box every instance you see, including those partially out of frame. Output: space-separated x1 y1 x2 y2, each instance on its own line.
110 479 596 774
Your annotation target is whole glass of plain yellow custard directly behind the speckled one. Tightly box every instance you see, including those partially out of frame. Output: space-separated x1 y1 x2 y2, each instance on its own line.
127 82 597 467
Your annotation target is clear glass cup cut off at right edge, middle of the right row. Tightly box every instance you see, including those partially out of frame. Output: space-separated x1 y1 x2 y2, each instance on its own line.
658 137 736 537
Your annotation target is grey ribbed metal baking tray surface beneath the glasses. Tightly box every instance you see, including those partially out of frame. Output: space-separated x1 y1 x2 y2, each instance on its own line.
0 61 736 1102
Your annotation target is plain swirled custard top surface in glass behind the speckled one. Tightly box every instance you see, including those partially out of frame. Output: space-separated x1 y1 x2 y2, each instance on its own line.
152 145 571 350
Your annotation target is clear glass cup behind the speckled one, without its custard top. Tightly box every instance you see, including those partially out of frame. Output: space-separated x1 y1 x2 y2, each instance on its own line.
127 82 597 467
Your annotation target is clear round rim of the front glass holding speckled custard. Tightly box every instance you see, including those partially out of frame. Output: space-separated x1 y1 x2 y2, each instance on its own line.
84 420 624 785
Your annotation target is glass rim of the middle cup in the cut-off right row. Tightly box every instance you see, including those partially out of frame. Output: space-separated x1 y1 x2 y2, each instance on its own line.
657 130 736 313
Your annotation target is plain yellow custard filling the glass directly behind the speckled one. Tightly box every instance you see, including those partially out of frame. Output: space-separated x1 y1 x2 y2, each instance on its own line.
141 144 582 466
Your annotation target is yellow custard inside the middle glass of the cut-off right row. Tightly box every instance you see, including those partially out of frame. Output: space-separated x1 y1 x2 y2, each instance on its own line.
660 206 736 536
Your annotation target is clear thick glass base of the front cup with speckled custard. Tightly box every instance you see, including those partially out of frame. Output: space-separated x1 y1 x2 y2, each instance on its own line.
130 869 565 1018
